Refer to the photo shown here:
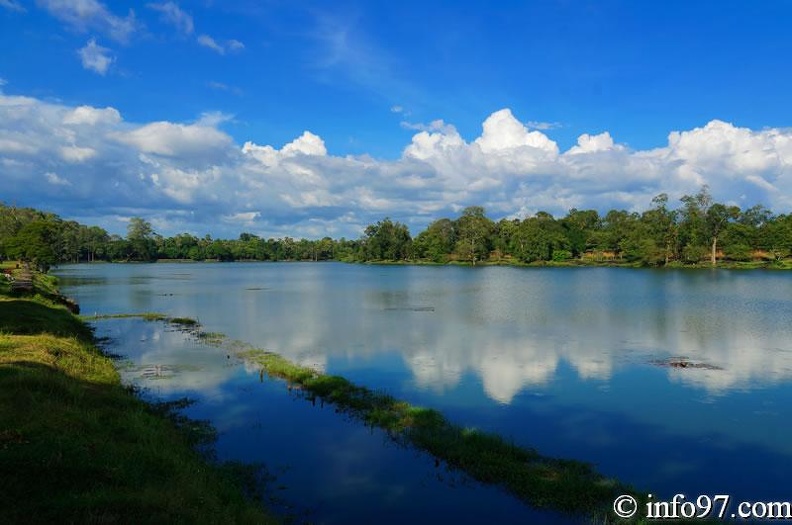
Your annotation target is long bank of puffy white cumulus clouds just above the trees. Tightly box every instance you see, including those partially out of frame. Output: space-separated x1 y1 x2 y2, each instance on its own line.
0 93 792 238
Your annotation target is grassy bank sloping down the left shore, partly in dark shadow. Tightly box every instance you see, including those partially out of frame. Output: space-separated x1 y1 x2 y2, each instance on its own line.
0 266 275 524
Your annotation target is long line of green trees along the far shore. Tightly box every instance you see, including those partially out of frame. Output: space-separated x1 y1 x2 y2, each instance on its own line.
0 186 792 268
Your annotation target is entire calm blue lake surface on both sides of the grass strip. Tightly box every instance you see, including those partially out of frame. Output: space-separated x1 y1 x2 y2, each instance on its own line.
57 263 792 523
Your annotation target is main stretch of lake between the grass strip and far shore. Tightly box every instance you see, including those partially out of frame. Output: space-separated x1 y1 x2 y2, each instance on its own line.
58 264 792 508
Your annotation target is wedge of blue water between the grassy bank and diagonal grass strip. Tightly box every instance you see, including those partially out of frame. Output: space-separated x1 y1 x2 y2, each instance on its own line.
91 319 582 525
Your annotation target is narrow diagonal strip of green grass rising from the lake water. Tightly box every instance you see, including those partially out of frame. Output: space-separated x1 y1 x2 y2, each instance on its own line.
238 350 638 520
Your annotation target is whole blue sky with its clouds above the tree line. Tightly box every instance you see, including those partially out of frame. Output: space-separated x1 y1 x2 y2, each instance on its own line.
0 0 792 239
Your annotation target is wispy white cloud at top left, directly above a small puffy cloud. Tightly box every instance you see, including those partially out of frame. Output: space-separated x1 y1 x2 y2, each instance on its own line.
36 0 137 42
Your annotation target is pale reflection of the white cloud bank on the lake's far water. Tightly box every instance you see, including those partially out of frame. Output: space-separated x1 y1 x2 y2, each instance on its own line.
58 265 792 396
